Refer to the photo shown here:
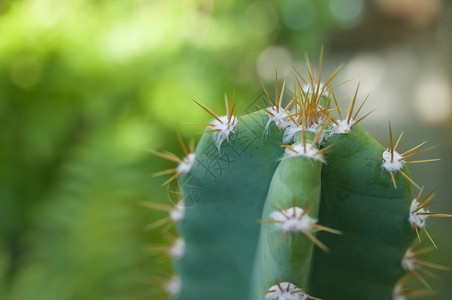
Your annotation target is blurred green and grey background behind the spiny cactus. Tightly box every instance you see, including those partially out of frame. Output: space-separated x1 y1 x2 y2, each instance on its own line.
0 0 452 300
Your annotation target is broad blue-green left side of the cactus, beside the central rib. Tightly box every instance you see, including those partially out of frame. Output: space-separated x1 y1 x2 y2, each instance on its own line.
176 106 283 299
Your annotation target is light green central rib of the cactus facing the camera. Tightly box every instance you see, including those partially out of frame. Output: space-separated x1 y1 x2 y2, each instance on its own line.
251 131 340 299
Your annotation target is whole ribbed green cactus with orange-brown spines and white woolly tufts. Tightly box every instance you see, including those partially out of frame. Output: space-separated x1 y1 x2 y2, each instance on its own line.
149 57 451 300
